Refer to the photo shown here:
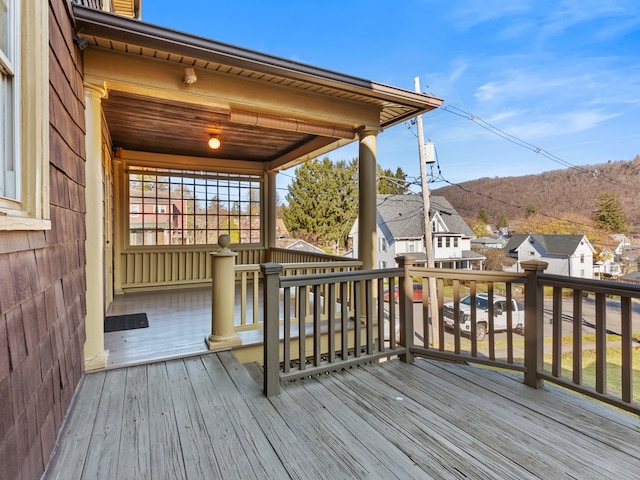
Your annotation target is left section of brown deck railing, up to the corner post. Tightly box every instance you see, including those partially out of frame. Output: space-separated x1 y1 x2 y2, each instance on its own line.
261 263 409 395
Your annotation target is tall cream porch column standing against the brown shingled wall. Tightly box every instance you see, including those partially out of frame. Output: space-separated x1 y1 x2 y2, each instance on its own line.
84 84 109 370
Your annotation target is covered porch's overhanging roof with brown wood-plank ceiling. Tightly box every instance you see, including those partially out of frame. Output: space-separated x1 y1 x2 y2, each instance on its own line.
73 5 442 170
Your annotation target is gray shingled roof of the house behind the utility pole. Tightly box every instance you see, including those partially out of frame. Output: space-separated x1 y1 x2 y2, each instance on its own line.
377 194 473 240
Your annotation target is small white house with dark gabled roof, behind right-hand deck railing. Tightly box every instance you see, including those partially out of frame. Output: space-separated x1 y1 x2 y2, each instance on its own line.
504 234 595 278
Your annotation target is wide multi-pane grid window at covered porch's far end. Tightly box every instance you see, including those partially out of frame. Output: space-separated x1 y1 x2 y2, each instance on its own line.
128 167 262 246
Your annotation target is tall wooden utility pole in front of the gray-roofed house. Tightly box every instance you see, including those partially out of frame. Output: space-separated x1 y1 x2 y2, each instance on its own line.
413 77 440 346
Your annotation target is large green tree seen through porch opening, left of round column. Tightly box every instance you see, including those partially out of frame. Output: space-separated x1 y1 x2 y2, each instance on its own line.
283 157 358 247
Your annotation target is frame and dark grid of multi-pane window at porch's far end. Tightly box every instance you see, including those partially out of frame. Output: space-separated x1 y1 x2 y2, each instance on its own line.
124 166 265 250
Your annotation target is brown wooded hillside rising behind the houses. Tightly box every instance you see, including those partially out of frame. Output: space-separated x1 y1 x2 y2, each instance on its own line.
432 155 640 236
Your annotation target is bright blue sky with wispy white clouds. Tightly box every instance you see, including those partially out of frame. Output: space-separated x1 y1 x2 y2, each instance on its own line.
142 0 640 193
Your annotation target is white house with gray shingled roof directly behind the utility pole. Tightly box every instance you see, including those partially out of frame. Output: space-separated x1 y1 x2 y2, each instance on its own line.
349 194 485 269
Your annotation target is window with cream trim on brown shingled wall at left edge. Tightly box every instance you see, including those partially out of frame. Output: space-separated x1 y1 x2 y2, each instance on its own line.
0 0 51 230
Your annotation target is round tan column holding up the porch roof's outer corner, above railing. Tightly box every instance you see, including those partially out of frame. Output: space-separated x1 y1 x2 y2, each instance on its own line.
358 129 378 270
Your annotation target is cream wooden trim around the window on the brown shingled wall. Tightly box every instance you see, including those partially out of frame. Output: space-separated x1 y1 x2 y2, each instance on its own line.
0 0 51 230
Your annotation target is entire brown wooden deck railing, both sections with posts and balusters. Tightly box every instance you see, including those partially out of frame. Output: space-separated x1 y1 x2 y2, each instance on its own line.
262 258 640 414
